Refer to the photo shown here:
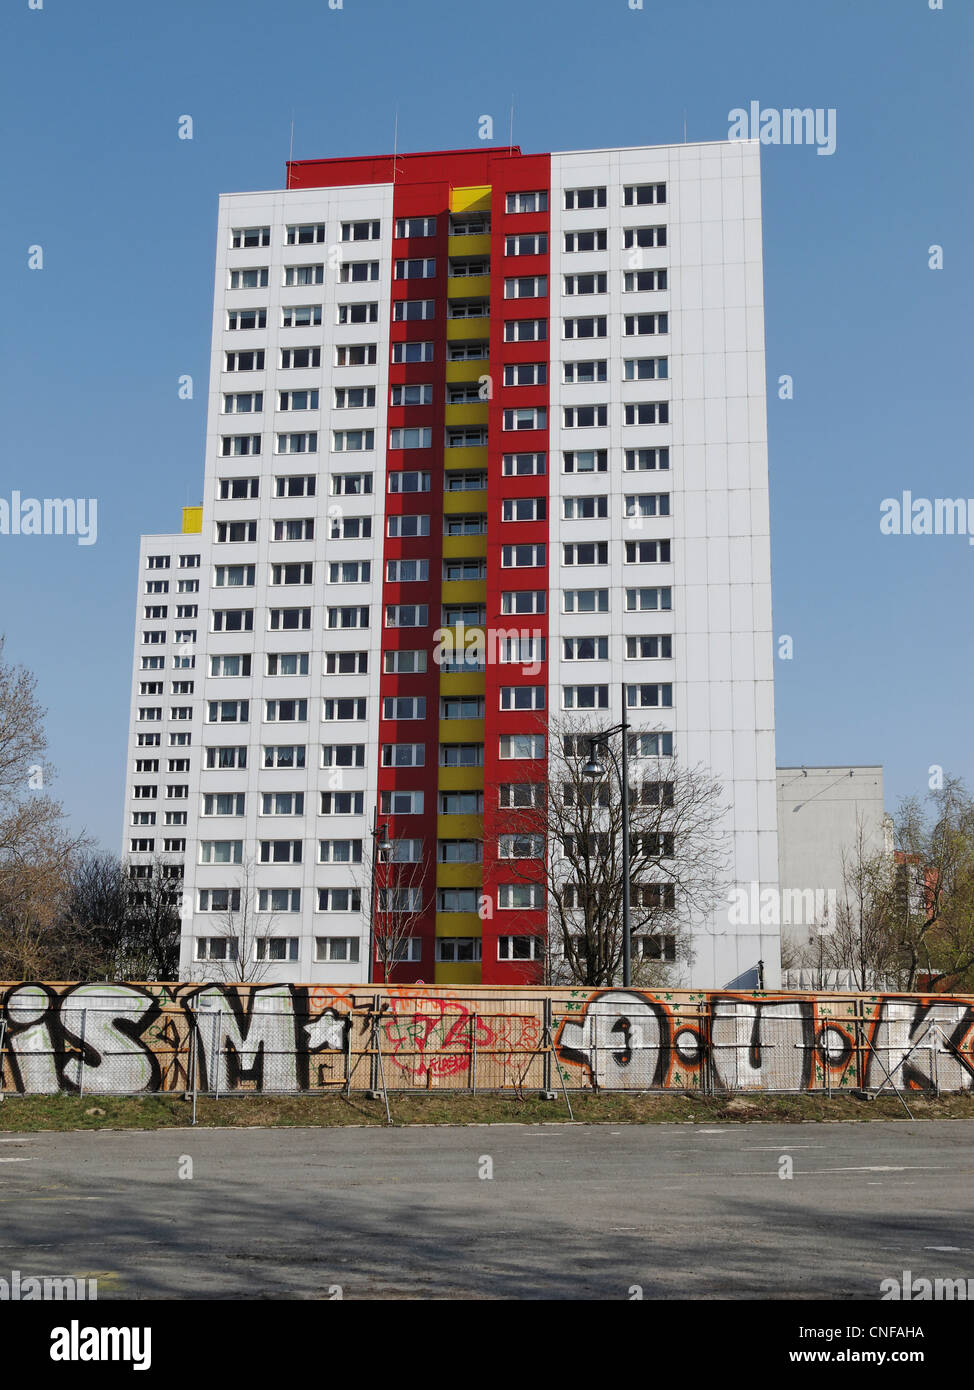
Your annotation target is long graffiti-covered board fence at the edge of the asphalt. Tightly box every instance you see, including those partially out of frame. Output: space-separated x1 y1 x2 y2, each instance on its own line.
0 981 974 1095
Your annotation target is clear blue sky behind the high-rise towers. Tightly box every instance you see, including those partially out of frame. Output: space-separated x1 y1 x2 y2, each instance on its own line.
0 0 974 849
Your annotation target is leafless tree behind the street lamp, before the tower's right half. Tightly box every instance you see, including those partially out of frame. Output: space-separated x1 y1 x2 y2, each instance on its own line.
490 719 727 986
